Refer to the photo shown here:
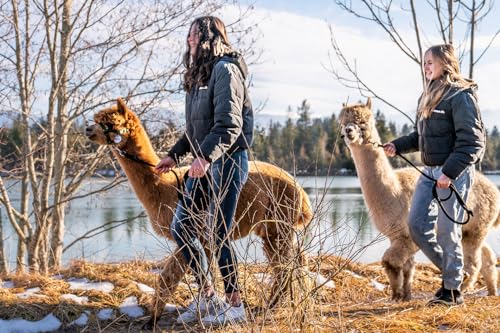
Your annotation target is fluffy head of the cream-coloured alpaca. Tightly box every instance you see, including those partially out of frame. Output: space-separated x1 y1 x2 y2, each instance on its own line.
339 97 378 147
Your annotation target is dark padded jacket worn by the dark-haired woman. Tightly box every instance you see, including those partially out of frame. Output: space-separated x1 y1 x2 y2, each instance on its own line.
168 56 253 162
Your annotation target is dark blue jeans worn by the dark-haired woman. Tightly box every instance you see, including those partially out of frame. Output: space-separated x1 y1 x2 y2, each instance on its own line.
171 150 248 293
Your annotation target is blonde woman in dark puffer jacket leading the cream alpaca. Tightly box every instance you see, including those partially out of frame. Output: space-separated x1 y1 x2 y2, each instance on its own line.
384 44 485 305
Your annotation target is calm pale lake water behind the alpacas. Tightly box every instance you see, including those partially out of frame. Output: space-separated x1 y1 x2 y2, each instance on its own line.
2 175 500 267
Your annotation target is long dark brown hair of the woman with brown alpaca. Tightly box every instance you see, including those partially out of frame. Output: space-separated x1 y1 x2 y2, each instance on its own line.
183 16 237 92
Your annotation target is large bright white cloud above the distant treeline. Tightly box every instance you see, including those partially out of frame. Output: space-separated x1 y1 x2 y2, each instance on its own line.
223 7 500 127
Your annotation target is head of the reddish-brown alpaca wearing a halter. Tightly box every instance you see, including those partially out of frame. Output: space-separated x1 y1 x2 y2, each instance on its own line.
85 98 140 147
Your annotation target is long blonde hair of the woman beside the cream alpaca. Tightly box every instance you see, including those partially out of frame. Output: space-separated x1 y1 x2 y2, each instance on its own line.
418 44 477 118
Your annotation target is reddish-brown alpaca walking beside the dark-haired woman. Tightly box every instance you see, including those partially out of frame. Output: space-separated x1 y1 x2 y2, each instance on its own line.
86 99 312 322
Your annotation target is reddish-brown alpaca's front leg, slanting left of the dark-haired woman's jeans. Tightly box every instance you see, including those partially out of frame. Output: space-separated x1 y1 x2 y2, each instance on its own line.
144 249 187 329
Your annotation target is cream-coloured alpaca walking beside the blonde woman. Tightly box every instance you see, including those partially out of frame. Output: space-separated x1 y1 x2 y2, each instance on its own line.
339 98 500 300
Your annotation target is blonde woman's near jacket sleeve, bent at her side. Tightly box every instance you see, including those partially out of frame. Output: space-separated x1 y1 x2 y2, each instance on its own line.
443 91 486 179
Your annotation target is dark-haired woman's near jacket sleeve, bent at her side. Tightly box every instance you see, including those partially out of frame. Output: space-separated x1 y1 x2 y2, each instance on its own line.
200 62 245 162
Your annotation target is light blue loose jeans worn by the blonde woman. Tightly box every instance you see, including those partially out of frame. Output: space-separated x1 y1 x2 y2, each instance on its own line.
409 166 475 289
